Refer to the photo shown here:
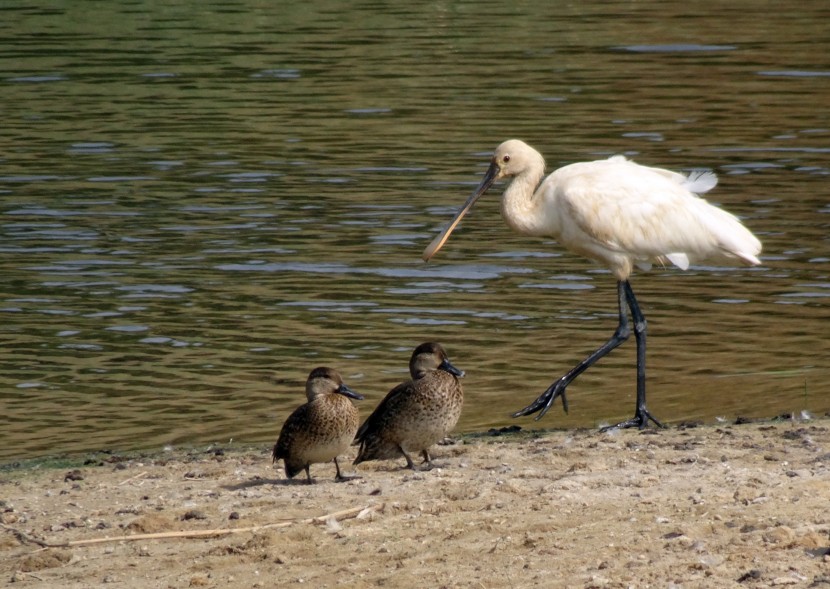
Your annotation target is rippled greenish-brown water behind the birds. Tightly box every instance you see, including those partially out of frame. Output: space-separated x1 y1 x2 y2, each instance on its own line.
0 0 830 461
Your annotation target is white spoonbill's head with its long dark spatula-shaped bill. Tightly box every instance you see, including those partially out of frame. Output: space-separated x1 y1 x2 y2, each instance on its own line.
423 139 545 262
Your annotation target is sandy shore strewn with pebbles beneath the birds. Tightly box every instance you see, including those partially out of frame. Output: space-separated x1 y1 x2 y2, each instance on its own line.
0 419 830 589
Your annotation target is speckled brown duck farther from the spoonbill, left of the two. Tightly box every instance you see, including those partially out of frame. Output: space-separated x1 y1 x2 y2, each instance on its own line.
271 367 363 484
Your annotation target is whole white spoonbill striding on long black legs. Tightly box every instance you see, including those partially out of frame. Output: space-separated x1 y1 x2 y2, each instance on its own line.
424 139 761 429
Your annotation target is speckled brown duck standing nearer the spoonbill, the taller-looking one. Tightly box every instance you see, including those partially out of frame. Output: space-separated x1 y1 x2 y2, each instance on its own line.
354 342 464 469
